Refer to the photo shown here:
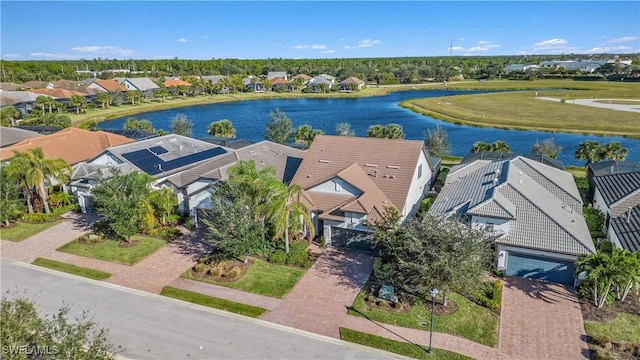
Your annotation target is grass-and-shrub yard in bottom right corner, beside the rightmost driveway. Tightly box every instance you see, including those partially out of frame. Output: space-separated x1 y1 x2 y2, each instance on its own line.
580 294 640 359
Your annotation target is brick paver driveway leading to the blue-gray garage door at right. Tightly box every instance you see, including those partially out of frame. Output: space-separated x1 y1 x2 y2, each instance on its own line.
498 277 589 360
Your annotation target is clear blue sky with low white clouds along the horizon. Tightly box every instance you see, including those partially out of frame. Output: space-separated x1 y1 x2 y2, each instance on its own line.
0 0 640 60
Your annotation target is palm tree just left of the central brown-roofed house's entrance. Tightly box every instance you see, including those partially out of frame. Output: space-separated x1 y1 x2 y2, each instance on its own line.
268 182 315 254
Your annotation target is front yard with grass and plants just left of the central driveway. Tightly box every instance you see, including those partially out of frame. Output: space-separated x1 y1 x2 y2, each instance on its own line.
182 258 305 298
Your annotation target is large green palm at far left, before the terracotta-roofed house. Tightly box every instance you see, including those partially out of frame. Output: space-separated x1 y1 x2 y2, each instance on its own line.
6 148 71 214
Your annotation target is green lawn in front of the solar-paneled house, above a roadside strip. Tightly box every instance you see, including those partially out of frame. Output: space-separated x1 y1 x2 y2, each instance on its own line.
56 235 167 265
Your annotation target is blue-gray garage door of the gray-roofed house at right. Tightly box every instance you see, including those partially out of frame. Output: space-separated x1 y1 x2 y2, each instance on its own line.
506 252 576 285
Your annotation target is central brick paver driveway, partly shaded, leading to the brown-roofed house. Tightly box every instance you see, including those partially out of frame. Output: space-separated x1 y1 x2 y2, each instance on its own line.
262 248 373 338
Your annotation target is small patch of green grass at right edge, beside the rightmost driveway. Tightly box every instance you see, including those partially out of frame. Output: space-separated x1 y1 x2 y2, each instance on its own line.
584 313 640 346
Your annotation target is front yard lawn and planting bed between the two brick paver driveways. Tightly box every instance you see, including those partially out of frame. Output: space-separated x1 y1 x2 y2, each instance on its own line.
349 282 499 347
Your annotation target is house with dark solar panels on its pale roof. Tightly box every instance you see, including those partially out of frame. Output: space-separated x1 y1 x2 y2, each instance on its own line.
71 134 229 212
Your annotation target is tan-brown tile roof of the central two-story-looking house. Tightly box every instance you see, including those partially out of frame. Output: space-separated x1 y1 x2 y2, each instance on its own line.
292 135 426 211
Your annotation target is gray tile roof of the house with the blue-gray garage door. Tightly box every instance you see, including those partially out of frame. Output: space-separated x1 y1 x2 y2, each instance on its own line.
429 156 595 255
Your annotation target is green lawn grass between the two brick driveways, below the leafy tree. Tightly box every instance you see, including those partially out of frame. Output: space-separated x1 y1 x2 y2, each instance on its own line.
349 290 498 347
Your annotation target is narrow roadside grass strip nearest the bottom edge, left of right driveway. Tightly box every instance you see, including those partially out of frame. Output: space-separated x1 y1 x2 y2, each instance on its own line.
340 327 472 360
